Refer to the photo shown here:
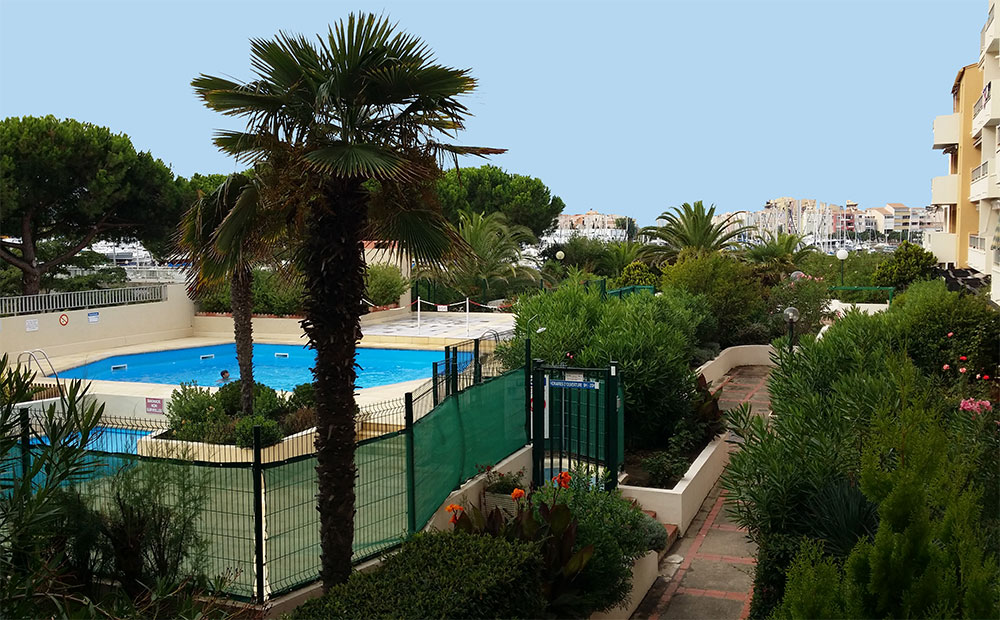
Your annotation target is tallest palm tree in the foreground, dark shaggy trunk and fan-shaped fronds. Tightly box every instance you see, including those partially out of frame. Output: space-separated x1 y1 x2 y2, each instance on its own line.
192 14 503 589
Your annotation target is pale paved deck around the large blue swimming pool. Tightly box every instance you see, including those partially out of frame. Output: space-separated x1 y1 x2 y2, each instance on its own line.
34 312 514 413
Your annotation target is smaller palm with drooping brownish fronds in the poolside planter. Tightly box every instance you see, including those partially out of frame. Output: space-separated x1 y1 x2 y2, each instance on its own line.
175 174 275 415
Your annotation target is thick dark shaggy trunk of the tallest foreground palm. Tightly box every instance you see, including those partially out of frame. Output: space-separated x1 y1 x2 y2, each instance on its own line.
301 180 368 591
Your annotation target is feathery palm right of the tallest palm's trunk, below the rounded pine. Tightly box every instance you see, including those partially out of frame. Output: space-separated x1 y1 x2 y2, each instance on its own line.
427 210 539 297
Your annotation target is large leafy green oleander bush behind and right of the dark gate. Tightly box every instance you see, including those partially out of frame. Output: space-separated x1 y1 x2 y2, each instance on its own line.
500 285 705 447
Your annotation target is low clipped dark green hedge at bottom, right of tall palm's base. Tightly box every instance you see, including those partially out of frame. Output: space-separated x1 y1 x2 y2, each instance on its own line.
292 532 545 620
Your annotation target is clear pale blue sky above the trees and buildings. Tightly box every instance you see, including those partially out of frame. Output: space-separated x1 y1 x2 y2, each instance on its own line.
0 0 987 223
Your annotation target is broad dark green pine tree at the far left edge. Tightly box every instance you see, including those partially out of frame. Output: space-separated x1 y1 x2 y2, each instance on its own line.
0 116 187 295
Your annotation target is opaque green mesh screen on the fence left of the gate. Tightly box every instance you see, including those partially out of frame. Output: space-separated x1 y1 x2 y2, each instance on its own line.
413 369 527 527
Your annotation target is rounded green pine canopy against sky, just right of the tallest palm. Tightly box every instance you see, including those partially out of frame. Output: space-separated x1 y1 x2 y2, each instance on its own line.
438 165 566 237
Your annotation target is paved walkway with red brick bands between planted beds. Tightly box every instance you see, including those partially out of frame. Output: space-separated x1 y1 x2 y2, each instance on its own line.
632 366 771 620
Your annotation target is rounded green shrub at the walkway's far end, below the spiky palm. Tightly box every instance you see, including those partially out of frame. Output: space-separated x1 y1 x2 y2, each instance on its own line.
662 252 771 348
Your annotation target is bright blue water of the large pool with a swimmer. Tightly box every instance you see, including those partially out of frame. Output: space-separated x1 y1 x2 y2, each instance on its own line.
59 344 442 391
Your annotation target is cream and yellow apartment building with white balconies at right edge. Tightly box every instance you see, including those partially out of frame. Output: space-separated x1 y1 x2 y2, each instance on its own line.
924 0 1000 302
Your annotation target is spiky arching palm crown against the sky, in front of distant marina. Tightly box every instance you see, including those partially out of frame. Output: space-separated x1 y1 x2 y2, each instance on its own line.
641 200 753 263
